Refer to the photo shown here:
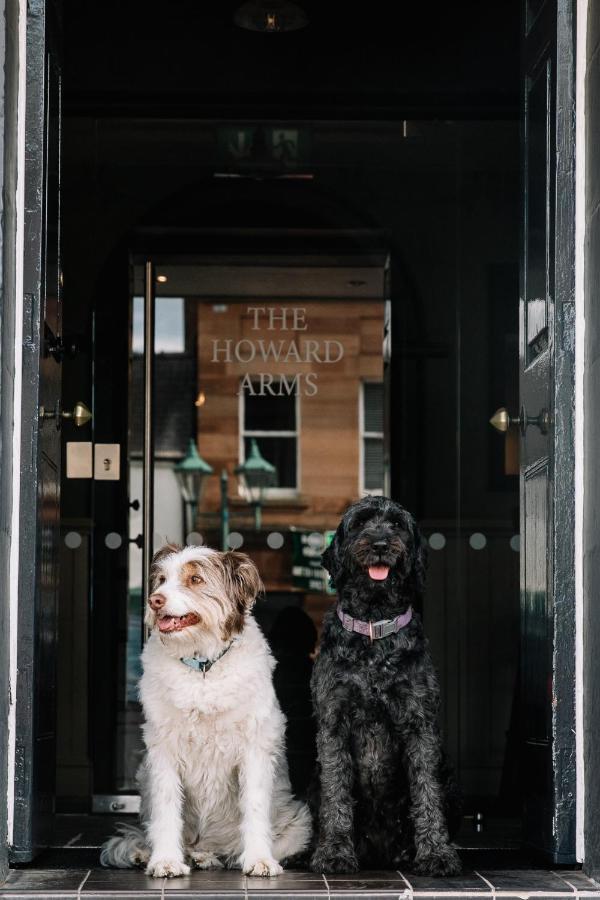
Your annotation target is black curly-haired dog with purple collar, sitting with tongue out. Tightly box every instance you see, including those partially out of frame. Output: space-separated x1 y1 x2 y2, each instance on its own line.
311 497 461 875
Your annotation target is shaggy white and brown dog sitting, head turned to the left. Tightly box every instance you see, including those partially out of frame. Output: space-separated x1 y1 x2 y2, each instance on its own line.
101 545 311 878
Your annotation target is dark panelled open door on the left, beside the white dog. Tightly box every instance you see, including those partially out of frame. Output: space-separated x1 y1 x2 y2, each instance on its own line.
11 2 64 862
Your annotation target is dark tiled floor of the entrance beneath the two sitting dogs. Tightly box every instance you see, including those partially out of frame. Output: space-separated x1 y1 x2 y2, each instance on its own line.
0 816 600 900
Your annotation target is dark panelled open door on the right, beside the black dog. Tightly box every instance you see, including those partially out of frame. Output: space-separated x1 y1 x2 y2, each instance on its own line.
513 0 576 863
